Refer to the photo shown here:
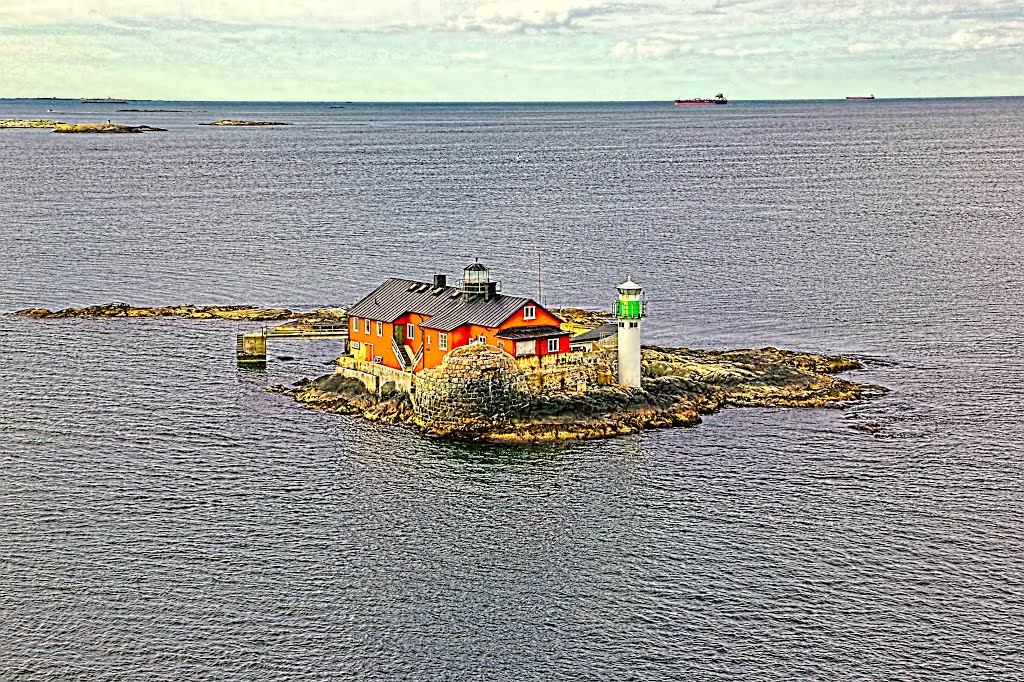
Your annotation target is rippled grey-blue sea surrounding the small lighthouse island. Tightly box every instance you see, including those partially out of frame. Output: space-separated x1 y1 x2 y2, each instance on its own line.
0 97 1024 682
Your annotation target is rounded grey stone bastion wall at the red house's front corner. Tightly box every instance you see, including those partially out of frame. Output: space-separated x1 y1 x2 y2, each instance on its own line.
414 343 526 430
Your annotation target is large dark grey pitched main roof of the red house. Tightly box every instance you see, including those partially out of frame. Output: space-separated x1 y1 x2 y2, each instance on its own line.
348 278 531 332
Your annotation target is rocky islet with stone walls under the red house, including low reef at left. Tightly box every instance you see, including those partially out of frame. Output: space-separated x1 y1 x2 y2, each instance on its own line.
15 294 885 443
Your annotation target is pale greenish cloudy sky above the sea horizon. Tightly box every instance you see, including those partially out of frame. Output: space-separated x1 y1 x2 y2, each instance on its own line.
0 0 1024 101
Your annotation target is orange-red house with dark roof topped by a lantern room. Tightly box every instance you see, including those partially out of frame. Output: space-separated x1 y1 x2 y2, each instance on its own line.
348 262 569 372
